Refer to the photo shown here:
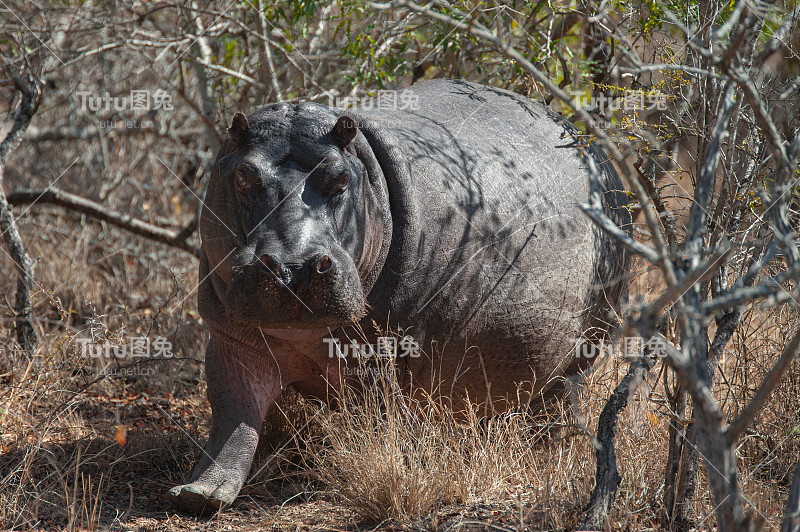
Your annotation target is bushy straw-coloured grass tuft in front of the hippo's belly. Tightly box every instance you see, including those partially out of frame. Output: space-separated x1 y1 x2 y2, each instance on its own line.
308 359 547 521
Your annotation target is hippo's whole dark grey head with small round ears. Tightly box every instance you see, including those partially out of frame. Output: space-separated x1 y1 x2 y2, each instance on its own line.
200 103 391 329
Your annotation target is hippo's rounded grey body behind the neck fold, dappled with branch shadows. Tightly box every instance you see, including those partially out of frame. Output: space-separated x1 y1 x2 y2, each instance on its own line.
353 80 630 408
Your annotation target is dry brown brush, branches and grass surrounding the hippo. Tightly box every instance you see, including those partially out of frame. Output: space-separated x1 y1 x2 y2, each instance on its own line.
0 0 800 530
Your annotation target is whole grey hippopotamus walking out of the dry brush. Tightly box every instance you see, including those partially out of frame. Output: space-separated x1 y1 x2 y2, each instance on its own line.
168 80 631 512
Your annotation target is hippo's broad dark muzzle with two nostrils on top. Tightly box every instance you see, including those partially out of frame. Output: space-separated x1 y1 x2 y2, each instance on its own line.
225 255 366 329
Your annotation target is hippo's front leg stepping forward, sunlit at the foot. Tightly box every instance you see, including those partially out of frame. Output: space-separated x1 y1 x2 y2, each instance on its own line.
167 335 281 513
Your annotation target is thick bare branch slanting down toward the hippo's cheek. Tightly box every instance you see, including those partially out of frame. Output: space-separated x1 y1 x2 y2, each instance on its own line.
8 187 200 258
